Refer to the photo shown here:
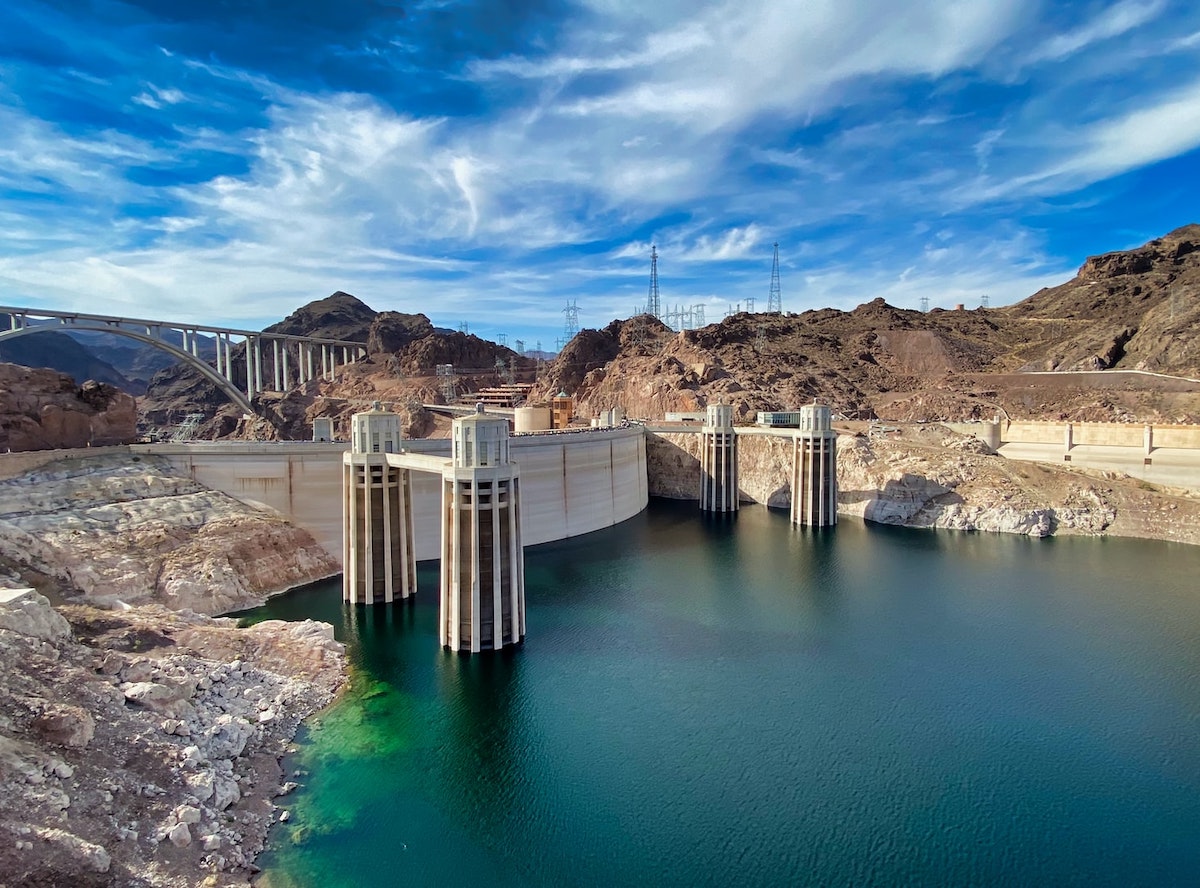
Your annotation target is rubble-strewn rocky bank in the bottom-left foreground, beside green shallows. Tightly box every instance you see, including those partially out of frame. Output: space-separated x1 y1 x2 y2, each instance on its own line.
0 592 344 888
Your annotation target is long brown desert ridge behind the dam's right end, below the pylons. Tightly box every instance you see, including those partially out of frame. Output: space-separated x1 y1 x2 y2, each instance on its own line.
525 226 1200 422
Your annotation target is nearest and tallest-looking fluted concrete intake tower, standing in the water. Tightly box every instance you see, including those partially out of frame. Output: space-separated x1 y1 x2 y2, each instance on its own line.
438 408 526 653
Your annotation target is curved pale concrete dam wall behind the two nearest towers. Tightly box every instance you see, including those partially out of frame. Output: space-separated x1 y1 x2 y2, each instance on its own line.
135 426 649 560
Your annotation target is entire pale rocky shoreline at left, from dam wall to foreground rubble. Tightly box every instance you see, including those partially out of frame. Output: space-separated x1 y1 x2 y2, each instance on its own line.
0 455 346 888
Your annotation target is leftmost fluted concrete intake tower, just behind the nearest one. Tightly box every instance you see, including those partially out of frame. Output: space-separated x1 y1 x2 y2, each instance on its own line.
342 402 416 605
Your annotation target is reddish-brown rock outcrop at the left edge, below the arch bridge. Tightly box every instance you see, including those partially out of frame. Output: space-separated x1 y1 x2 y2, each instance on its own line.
0 364 137 452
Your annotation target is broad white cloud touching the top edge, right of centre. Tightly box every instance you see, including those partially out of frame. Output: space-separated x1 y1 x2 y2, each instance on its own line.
496 0 1028 132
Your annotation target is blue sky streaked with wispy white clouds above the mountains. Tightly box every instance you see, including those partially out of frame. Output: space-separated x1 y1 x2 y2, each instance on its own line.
0 0 1200 348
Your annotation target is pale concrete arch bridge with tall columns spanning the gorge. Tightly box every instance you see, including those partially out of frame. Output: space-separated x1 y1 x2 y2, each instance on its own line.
0 305 367 413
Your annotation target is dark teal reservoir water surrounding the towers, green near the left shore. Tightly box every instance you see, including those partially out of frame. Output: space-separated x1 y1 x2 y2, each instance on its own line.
243 502 1200 888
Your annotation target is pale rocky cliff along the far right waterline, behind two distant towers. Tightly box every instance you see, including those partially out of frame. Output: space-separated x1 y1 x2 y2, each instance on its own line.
647 425 1200 544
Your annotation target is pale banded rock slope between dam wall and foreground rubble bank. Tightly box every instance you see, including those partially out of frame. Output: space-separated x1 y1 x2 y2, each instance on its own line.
0 454 340 613
